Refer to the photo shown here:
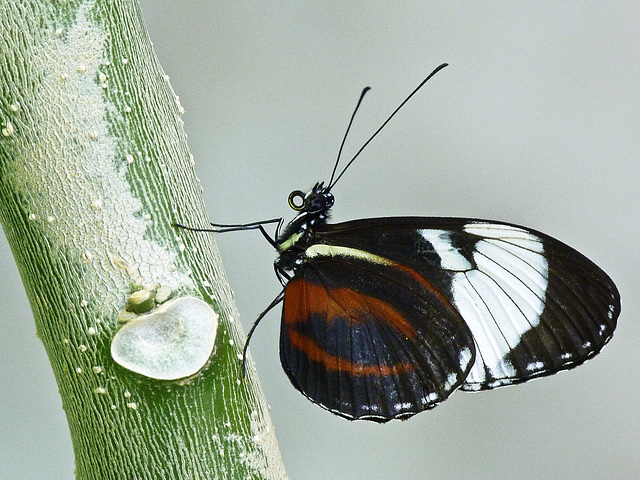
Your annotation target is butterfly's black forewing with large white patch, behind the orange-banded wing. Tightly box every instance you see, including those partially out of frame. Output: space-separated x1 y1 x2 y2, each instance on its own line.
311 217 620 390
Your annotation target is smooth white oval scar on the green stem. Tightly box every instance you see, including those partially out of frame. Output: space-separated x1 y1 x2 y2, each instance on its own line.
111 297 218 380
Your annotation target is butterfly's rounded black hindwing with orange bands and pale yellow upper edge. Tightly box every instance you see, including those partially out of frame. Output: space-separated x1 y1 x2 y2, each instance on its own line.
280 245 474 421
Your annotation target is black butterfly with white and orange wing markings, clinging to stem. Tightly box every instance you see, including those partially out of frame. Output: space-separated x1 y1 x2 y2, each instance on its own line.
178 64 620 422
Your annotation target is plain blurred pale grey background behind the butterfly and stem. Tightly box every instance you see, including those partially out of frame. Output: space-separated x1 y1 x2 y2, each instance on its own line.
0 0 640 480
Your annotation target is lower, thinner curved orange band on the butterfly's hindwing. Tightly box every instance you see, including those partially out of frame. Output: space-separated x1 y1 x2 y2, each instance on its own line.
287 329 415 377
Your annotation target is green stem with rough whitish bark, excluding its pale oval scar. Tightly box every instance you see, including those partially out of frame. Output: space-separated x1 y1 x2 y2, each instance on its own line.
0 0 286 480
